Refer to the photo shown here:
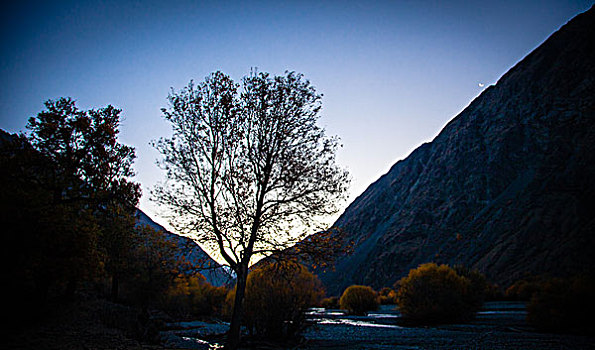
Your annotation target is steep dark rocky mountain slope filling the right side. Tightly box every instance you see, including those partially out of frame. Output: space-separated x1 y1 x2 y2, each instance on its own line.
318 8 595 294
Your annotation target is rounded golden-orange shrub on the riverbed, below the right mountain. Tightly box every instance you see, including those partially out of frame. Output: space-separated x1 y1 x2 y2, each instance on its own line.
397 263 485 324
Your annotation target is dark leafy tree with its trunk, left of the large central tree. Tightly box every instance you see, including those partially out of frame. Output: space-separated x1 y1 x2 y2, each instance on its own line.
27 98 140 299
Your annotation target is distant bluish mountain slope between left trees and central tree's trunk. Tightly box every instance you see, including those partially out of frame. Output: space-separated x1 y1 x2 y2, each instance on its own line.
136 209 233 286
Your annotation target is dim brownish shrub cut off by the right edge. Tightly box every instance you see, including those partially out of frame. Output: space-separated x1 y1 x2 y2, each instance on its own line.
527 276 595 334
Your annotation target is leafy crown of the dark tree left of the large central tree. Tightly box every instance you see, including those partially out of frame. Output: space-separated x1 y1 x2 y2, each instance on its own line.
27 98 140 208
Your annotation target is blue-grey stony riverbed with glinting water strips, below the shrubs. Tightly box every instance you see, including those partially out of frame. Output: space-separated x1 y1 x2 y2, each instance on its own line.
164 302 595 350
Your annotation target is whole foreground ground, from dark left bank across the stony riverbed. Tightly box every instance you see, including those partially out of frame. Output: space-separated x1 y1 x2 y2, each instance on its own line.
0 302 595 350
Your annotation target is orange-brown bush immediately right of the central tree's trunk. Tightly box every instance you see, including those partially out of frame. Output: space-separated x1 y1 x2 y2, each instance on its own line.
232 262 323 340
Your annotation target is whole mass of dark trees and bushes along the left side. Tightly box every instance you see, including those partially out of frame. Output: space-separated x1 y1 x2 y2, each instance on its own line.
0 98 191 318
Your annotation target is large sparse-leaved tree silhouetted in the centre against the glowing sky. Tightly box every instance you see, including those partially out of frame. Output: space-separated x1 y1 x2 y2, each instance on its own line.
153 72 347 349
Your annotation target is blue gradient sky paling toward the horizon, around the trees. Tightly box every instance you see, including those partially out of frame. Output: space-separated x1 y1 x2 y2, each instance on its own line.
0 0 593 235
